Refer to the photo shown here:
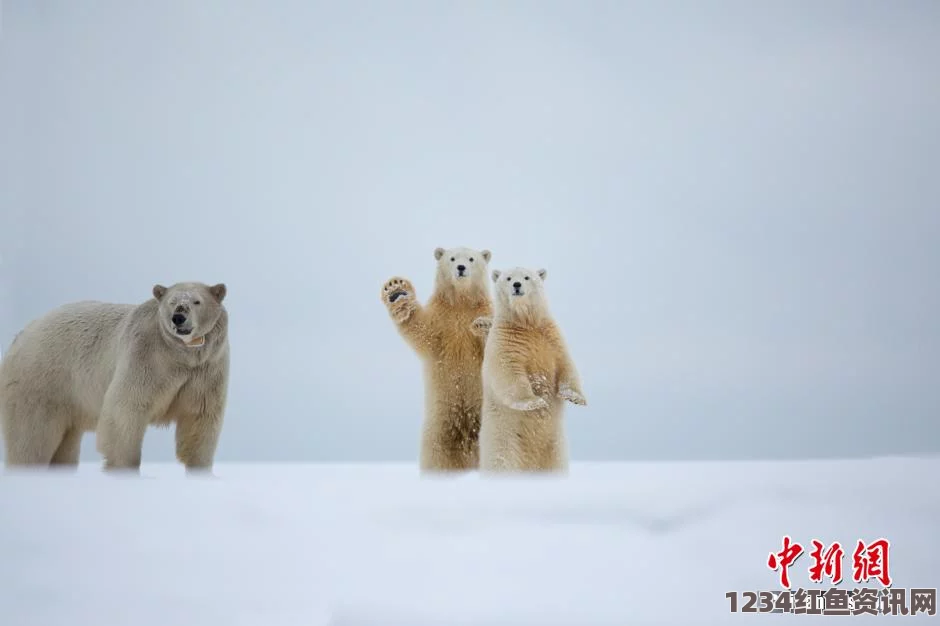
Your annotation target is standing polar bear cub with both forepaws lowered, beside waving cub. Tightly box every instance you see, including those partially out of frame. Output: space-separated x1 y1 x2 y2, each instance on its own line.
482 267 587 472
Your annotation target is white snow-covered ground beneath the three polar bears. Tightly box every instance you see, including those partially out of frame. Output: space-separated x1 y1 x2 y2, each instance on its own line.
0 458 940 626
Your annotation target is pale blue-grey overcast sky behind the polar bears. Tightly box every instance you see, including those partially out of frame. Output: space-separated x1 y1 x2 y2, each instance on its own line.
0 0 940 462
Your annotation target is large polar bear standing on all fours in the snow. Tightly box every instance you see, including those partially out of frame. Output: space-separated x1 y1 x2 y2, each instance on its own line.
0 282 229 470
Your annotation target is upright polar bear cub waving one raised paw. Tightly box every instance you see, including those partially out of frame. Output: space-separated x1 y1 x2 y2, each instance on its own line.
382 248 492 472
